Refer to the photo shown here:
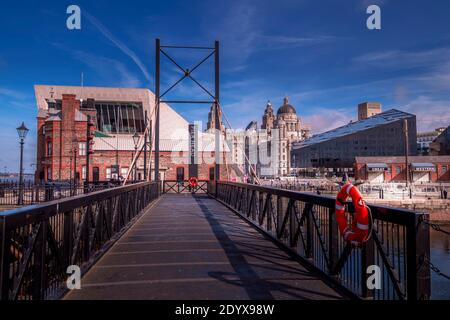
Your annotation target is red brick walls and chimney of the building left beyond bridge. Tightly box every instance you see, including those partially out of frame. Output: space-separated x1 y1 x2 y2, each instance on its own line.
36 94 233 181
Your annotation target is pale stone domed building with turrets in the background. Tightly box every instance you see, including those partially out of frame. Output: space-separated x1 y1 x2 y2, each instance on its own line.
261 97 309 176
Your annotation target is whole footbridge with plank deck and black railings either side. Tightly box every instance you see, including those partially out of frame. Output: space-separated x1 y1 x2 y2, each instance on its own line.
0 182 430 300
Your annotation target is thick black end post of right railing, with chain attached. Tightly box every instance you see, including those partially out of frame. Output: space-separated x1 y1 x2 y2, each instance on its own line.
406 214 431 301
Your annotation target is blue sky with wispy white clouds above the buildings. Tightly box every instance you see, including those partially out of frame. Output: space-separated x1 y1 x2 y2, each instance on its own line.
0 0 450 172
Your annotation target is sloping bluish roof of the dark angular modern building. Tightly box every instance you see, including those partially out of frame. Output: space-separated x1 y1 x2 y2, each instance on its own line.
294 109 415 149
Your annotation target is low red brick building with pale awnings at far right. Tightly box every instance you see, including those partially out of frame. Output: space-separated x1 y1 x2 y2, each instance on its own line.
354 156 450 183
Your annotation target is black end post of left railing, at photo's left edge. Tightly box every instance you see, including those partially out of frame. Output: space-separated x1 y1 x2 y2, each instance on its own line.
0 216 11 300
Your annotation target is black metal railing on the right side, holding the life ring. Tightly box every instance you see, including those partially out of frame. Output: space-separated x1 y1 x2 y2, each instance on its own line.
210 182 430 300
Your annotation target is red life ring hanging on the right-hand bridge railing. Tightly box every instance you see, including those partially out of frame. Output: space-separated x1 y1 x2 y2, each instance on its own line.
335 183 370 244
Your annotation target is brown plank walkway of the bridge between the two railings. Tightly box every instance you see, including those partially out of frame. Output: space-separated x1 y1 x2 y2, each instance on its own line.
65 194 341 300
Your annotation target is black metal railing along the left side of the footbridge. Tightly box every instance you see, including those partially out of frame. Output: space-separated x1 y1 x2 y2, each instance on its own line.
0 182 159 300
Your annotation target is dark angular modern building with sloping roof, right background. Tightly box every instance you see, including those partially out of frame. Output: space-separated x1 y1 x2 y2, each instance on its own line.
292 109 417 171
